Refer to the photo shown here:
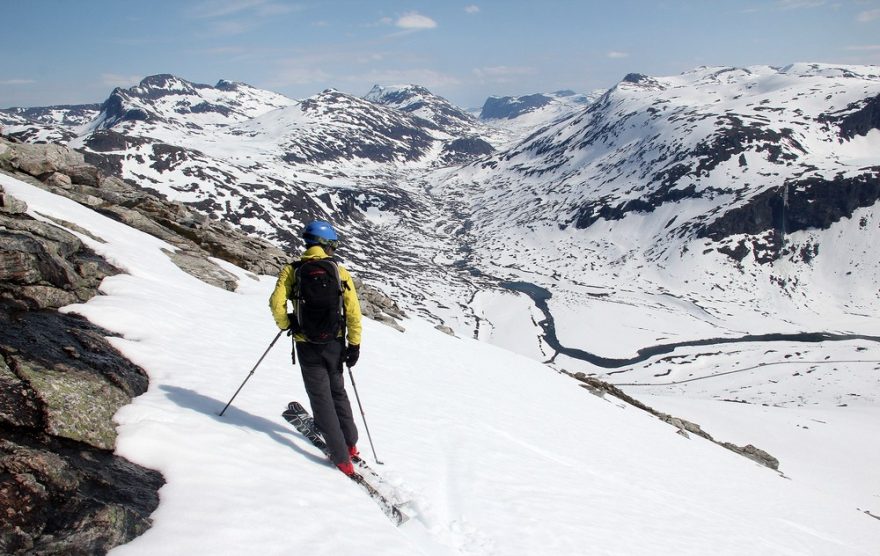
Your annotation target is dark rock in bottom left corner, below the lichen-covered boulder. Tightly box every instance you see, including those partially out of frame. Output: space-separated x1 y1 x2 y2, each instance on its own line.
0 424 164 555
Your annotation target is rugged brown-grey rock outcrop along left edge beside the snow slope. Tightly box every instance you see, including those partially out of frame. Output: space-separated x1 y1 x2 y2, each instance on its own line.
0 181 164 554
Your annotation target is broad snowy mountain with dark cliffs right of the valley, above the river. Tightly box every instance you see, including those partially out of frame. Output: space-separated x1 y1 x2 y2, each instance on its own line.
435 64 880 370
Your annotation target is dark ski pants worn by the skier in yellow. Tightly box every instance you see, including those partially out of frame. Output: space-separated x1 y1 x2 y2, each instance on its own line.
296 341 358 464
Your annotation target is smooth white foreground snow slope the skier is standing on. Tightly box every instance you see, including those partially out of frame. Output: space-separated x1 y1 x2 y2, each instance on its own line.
0 170 880 555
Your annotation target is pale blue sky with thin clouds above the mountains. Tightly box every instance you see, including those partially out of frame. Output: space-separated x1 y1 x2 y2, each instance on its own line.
0 0 880 108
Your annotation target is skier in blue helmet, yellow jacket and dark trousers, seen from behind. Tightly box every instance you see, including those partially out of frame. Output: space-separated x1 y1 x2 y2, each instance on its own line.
269 220 361 476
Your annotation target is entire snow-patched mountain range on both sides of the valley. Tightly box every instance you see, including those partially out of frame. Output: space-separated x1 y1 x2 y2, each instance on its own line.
1 64 880 360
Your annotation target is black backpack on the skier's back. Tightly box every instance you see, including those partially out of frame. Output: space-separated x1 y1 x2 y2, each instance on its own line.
290 259 345 344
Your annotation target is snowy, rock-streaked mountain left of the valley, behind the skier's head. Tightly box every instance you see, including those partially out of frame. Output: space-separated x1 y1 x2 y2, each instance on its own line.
3 75 512 332
